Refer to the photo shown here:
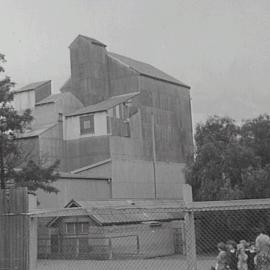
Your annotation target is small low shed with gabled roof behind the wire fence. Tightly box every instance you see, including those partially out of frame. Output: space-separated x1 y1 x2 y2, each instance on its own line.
39 200 184 259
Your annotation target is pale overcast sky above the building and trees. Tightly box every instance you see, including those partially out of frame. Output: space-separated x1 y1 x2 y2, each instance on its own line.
0 0 270 123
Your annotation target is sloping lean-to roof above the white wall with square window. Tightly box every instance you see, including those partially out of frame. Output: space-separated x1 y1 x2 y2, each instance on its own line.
66 92 140 117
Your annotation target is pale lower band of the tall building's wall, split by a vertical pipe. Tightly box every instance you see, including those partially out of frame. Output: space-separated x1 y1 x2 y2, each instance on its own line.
112 159 185 199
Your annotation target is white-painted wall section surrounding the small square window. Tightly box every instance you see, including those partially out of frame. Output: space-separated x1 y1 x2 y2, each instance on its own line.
64 112 108 140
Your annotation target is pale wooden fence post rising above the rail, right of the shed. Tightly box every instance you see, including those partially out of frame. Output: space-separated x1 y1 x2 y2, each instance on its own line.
183 184 197 270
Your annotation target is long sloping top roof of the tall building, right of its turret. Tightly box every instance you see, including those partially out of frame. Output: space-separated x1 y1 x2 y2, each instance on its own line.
108 52 190 88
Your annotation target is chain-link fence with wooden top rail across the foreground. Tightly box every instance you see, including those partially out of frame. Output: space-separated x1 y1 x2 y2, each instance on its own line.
33 200 270 270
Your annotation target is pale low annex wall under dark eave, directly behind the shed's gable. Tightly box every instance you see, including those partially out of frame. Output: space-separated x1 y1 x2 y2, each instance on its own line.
37 179 111 209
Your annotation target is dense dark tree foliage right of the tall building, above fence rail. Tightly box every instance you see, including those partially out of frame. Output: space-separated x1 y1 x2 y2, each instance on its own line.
186 115 270 200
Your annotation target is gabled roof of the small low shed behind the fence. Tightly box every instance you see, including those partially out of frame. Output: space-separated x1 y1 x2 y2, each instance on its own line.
48 200 184 226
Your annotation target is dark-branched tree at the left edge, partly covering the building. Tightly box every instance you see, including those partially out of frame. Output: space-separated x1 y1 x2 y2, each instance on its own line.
0 54 59 192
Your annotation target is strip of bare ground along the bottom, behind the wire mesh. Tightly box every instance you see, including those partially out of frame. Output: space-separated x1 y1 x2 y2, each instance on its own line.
37 257 215 270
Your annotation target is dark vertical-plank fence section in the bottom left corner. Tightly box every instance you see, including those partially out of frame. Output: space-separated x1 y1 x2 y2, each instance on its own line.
0 188 29 270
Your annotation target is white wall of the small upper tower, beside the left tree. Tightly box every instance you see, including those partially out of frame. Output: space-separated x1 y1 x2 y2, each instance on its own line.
12 90 35 111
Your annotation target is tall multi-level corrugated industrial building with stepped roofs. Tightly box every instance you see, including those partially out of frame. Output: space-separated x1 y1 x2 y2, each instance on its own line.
14 35 193 208
